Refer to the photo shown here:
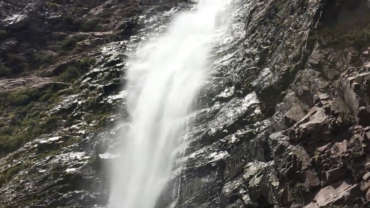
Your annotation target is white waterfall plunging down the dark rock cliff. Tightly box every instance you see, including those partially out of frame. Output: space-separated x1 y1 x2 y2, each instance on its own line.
109 0 229 208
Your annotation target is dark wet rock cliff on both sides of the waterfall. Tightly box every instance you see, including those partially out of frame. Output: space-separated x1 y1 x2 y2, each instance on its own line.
0 0 370 208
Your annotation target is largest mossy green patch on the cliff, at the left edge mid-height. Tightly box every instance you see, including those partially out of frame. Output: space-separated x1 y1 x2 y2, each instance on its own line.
0 86 66 155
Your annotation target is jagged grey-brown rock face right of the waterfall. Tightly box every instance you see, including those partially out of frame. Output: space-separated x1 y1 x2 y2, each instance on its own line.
179 0 370 208
